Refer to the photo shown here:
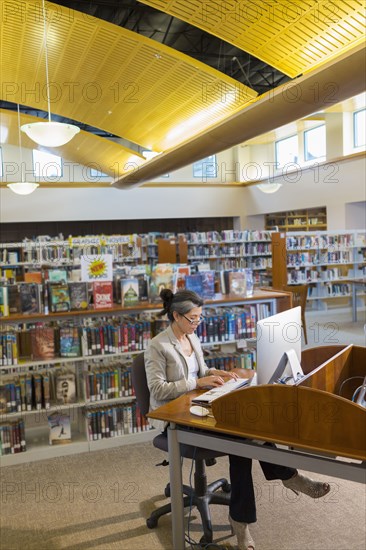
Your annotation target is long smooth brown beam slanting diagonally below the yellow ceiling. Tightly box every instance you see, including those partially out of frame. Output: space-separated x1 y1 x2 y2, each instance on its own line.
113 45 366 189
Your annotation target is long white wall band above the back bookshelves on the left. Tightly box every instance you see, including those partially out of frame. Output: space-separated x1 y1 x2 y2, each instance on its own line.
0 187 245 224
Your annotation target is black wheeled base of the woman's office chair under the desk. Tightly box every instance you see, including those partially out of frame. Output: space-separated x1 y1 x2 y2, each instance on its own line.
146 460 230 543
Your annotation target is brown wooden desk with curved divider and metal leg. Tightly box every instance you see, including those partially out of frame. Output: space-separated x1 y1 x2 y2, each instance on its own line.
149 346 366 550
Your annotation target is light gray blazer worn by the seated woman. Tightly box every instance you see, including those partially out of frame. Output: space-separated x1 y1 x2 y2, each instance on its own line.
145 326 211 429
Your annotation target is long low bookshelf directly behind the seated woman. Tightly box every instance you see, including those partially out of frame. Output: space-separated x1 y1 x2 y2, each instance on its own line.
0 290 291 466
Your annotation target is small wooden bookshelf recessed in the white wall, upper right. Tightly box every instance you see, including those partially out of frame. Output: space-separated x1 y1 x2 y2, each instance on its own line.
265 206 327 231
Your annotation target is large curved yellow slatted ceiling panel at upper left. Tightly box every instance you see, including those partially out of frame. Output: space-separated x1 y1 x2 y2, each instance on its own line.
0 0 257 151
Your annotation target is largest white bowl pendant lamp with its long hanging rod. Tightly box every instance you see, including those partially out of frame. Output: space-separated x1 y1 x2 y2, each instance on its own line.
21 0 80 147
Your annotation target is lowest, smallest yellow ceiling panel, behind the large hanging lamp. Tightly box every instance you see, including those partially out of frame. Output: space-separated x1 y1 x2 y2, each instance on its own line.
0 109 146 177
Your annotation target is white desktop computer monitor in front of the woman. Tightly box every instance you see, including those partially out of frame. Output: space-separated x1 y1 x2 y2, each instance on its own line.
256 306 303 384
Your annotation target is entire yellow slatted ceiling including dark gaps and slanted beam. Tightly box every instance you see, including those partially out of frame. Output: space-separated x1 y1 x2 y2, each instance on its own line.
0 0 365 188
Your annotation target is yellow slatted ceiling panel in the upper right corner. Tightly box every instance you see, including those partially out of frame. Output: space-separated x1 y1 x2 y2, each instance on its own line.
140 0 365 78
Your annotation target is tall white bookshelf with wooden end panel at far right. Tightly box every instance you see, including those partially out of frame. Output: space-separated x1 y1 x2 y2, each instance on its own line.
272 230 366 309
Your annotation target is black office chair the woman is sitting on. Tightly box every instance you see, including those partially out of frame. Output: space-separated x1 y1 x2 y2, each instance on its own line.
131 353 230 543
